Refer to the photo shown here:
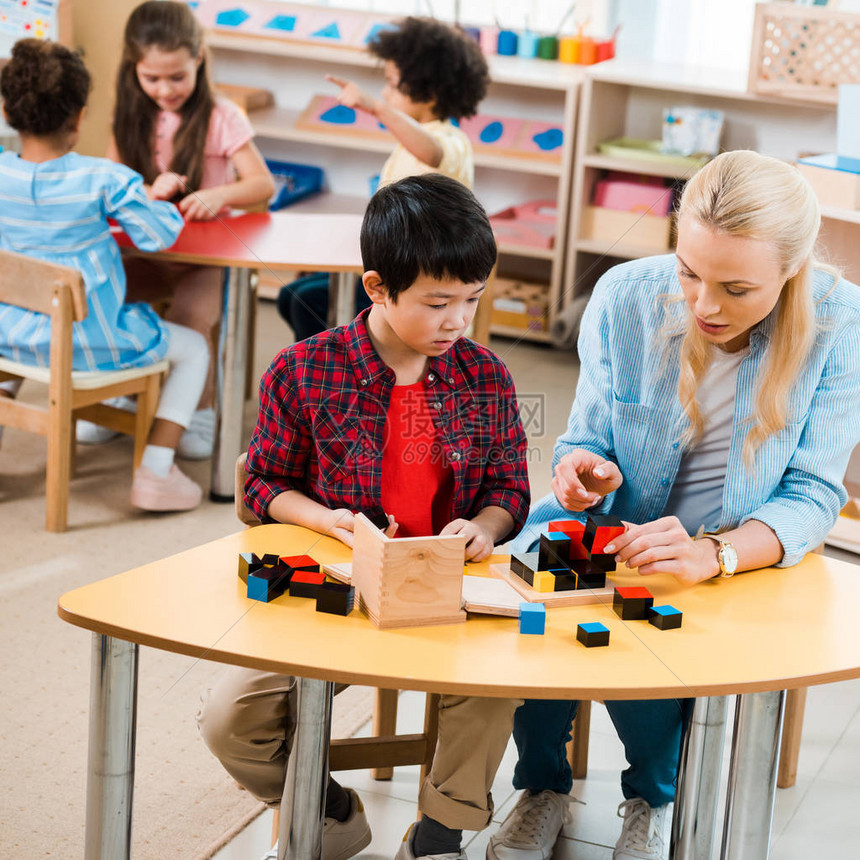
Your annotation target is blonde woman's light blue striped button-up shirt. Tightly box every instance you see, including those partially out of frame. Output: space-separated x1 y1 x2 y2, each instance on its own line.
512 255 860 566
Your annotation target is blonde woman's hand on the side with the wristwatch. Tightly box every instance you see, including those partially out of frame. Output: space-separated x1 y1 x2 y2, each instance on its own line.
606 517 720 585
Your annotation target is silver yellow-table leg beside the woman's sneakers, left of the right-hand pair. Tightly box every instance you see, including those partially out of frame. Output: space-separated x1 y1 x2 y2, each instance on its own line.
669 696 727 860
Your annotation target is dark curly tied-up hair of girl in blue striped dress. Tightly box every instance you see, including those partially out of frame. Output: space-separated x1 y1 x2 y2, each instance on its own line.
0 39 90 137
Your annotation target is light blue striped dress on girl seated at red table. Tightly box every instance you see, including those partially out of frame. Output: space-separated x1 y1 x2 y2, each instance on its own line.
0 152 183 370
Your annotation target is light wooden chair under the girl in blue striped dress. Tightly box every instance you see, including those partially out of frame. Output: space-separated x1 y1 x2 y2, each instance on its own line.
0 251 168 532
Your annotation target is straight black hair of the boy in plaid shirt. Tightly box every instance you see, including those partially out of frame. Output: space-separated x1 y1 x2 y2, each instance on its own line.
361 173 496 302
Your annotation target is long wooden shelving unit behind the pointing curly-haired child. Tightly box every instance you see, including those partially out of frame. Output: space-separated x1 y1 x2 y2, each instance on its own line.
206 17 584 341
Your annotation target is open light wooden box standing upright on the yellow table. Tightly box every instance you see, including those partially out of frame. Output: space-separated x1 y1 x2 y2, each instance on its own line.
352 514 466 630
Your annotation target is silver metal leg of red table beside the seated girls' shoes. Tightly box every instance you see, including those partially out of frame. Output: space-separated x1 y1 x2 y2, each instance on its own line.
209 268 251 502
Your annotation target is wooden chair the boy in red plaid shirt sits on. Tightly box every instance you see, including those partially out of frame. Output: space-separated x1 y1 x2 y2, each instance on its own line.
235 454 439 800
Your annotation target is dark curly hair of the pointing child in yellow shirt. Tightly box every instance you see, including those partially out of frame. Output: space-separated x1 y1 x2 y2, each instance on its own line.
367 17 490 119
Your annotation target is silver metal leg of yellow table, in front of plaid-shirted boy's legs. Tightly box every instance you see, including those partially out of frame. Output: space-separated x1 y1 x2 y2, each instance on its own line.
278 678 334 860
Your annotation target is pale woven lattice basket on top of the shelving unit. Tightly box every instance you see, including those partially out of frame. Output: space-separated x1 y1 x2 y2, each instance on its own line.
749 3 860 104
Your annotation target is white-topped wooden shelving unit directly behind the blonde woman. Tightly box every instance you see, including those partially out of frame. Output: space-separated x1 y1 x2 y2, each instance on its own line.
562 60 840 314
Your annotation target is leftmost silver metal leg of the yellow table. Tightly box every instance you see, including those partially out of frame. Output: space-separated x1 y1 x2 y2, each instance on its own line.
84 633 138 860
